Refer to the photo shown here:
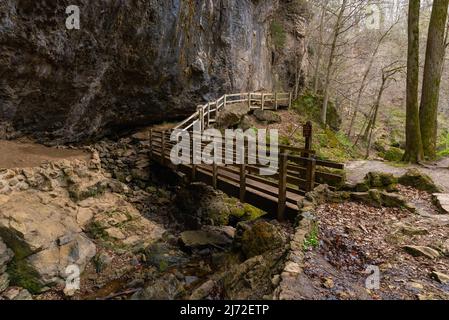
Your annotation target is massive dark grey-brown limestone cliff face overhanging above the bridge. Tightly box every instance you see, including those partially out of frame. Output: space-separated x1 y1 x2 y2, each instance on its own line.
0 0 306 141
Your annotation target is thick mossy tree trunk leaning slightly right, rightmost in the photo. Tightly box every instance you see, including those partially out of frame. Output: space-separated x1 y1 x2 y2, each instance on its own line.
419 0 449 159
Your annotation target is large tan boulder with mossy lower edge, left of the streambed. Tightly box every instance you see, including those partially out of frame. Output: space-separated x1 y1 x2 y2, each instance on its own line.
0 191 96 292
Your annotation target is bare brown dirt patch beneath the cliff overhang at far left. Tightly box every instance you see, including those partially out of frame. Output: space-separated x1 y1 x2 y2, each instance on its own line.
0 140 90 169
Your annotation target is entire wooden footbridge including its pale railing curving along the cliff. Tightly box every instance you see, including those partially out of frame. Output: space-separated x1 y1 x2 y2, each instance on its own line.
149 93 344 220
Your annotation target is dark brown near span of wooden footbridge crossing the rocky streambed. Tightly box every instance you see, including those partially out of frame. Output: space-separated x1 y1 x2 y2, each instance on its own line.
149 124 344 220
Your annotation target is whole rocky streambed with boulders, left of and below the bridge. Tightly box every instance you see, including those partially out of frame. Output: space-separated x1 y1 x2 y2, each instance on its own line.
0 134 292 299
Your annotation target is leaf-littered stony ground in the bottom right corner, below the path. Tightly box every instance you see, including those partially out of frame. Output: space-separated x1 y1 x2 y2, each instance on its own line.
299 186 449 300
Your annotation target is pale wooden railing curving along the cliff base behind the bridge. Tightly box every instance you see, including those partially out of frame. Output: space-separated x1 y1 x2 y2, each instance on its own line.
174 92 292 130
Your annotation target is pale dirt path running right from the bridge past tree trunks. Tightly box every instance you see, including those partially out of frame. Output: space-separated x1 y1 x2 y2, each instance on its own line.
346 158 449 192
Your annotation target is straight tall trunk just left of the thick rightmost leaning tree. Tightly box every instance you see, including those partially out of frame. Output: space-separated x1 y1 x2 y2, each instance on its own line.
403 0 424 163
